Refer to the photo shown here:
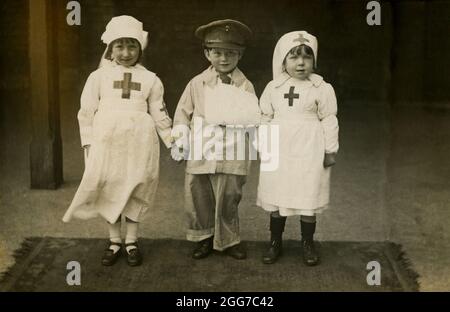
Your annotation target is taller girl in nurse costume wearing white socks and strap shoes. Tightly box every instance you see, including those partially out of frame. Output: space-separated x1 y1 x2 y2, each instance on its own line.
63 16 172 266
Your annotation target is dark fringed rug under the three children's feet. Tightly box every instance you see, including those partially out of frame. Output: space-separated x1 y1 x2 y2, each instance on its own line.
0 237 418 292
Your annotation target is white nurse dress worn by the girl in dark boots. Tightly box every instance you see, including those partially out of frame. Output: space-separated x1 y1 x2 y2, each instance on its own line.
257 74 339 216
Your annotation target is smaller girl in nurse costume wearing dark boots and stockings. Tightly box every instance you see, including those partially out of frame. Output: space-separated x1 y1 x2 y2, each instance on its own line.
257 31 339 266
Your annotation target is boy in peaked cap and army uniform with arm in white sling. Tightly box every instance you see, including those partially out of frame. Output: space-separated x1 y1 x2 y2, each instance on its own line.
172 20 259 259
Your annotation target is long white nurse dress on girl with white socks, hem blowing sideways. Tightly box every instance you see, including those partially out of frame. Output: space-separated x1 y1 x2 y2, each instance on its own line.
63 62 172 223
